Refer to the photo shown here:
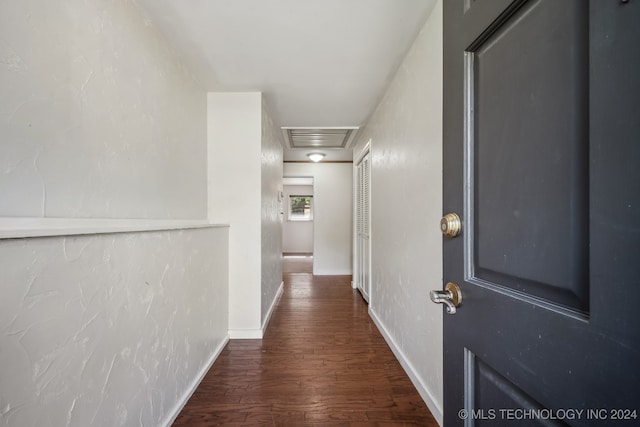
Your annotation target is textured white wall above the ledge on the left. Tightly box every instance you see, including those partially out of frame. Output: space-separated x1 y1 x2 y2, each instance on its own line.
0 0 206 218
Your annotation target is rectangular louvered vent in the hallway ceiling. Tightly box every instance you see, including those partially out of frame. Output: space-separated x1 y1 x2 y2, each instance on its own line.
282 126 359 148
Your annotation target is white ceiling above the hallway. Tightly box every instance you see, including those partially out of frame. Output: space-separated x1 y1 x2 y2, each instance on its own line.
136 0 434 160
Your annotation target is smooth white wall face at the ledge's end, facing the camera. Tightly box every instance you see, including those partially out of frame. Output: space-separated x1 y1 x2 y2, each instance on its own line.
207 92 262 338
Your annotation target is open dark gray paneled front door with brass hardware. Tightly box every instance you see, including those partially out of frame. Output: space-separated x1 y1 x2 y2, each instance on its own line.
443 0 640 426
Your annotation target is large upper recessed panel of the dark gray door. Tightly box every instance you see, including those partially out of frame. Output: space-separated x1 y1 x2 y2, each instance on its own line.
466 1 589 313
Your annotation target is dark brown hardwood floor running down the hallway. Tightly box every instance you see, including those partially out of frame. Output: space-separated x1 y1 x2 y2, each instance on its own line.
174 259 437 426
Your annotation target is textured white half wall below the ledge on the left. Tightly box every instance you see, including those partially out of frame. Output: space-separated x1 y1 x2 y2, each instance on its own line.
0 228 228 427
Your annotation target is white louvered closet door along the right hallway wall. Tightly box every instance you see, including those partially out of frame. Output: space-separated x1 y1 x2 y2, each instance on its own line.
356 153 371 301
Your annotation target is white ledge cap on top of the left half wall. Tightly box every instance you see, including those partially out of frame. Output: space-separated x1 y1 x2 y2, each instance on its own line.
0 217 228 239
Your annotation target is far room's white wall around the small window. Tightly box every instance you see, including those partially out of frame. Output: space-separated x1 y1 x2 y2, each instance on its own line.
282 185 313 253
